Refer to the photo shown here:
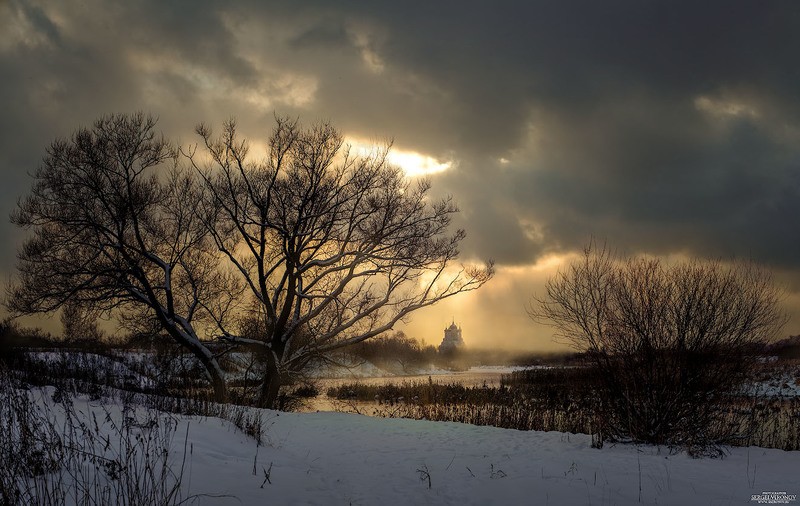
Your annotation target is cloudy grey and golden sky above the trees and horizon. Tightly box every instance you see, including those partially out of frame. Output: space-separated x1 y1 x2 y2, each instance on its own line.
0 0 800 350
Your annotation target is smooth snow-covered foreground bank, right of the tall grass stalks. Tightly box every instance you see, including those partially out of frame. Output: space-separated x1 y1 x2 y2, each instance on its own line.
14 392 800 506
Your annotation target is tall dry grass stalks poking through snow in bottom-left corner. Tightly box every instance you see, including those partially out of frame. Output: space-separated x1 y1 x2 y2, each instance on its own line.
0 371 189 506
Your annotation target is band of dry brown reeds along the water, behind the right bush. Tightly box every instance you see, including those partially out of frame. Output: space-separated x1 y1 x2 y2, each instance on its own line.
327 367 800 455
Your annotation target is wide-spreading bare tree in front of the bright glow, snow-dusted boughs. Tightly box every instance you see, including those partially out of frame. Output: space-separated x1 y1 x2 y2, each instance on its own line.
190 118 493 406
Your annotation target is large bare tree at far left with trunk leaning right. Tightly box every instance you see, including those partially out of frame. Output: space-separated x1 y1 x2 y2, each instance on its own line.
6 114 235 400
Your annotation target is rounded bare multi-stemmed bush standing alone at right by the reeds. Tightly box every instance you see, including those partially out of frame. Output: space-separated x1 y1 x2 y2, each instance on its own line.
529 243 785 447
